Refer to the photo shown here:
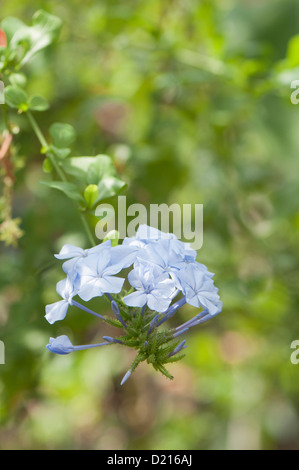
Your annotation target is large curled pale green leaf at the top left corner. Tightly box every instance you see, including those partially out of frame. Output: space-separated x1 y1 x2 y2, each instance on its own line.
9 10 62 66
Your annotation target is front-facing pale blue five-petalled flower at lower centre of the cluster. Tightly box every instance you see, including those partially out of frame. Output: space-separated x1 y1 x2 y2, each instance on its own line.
124 263 177 312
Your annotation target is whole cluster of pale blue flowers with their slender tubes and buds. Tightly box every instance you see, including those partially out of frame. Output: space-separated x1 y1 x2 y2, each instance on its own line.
45 225 222 383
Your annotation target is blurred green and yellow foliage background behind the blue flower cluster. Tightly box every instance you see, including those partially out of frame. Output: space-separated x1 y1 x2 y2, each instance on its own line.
0 0 299 450
